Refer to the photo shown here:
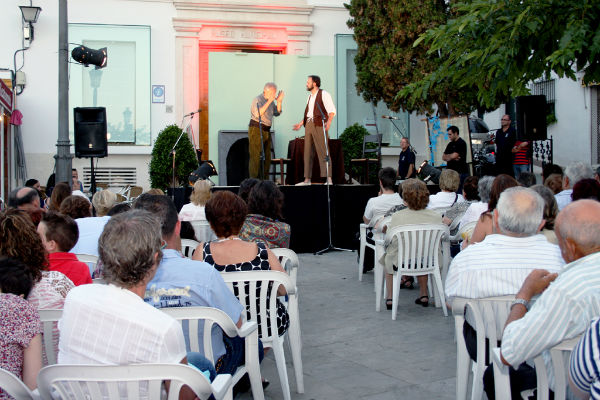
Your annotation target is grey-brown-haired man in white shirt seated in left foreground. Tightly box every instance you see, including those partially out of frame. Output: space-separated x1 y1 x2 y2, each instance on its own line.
58 210 216 392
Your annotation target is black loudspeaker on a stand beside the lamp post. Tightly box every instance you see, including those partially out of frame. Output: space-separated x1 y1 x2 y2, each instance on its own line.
73 107 108 158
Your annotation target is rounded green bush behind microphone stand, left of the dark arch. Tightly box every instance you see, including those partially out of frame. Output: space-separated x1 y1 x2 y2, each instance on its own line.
149 125 198 190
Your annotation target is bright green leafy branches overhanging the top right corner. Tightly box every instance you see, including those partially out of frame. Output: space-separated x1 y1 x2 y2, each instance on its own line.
399 0 600 108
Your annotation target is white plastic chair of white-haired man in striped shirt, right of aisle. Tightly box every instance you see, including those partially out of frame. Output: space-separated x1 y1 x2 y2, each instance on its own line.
452 295 515 400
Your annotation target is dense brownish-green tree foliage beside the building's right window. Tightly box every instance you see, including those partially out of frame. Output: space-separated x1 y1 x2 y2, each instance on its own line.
345 0 486 115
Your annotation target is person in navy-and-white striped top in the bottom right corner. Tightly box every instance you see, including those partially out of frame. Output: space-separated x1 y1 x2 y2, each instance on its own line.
569 319 600 400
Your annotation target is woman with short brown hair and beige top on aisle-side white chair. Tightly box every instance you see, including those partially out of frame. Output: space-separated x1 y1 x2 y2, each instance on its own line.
379 179 442 310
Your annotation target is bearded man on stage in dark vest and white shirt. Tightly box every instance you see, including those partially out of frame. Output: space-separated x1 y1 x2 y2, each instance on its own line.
293 75 336 186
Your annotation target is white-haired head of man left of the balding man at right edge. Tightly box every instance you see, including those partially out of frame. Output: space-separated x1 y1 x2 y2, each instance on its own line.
496 187 545 236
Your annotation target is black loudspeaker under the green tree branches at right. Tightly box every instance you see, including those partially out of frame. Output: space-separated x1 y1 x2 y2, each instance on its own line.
515 95 547 140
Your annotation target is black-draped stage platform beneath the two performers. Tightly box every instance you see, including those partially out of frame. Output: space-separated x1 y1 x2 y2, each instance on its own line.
169 184 379 253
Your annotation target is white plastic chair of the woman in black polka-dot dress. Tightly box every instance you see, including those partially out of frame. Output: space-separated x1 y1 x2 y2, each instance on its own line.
221 271 304 400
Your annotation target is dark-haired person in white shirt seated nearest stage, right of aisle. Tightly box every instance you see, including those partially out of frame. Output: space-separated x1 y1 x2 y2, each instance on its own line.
363 167 403 228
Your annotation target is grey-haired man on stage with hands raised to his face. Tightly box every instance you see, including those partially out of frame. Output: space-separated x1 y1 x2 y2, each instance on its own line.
248 82 285 179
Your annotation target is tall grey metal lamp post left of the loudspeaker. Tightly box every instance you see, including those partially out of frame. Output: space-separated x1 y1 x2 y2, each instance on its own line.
54 0 73 182
